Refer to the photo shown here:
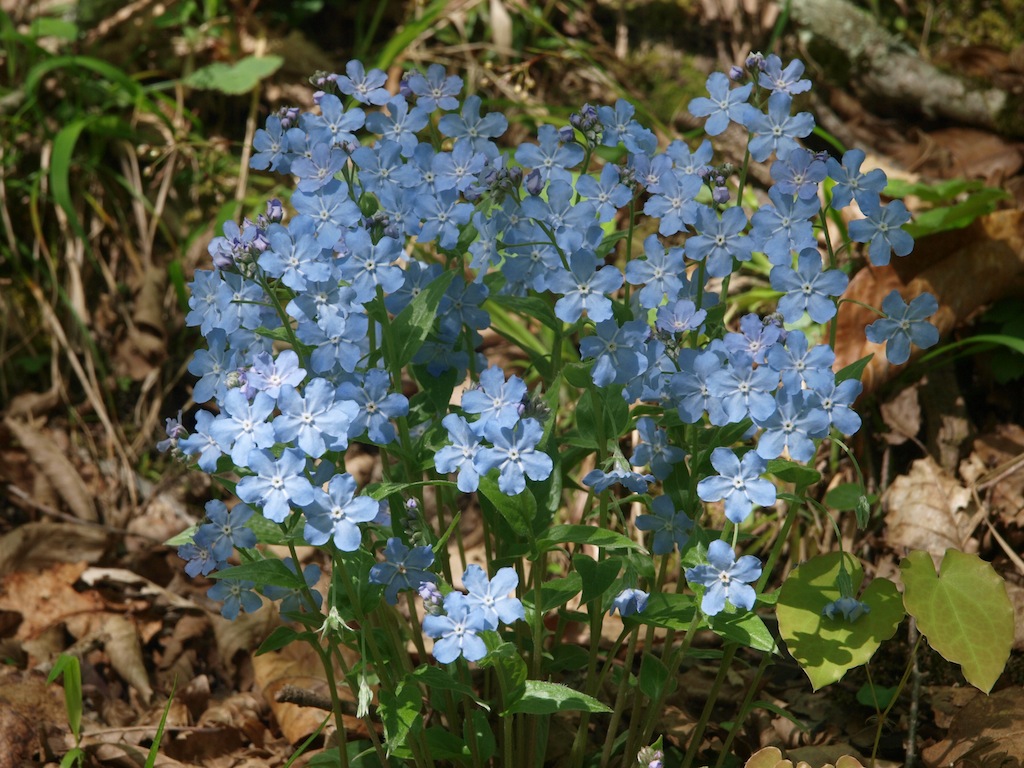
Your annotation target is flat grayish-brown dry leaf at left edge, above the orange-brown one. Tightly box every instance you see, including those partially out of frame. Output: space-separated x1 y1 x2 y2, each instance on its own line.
0 520 108 575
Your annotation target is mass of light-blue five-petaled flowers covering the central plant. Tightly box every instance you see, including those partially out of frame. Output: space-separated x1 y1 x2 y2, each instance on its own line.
164 51 937 634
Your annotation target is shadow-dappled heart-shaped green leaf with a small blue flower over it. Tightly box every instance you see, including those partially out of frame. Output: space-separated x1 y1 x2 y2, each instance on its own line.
775 552 904 690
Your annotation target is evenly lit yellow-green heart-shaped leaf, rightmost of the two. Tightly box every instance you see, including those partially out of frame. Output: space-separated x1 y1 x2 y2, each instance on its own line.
900 549 1014 693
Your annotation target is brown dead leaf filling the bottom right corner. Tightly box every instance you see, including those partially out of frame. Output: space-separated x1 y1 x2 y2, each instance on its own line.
921 687 1024 768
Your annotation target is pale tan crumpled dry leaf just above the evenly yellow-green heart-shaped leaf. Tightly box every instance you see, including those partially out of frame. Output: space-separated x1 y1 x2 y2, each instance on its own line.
882 457 977 565
